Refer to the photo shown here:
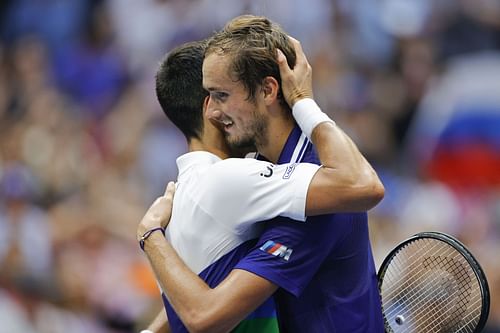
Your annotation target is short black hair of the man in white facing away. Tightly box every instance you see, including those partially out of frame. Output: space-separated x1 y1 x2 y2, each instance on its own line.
156 41 208 141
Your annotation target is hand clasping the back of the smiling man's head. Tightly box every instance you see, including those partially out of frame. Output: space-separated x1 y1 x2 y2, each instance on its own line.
276 36 313 107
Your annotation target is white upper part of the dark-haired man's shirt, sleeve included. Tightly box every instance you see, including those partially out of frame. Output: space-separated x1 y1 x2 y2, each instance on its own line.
166 151 320 274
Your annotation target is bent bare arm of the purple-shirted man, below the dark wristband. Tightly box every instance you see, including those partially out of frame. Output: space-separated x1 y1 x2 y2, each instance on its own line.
144 233 277 332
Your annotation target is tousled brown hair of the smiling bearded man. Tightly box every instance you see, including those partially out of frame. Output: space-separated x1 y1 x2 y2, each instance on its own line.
205 15 296 105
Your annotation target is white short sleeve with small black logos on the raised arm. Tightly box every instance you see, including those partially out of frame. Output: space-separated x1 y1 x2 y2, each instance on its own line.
198 158 320 230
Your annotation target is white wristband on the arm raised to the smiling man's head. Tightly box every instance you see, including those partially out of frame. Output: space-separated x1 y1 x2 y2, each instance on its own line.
292 98 335 139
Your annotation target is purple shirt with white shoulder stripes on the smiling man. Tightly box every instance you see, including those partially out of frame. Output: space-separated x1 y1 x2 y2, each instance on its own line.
235 127 384 333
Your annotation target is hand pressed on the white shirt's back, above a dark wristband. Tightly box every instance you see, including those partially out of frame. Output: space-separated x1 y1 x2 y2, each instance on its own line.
137 182 175 240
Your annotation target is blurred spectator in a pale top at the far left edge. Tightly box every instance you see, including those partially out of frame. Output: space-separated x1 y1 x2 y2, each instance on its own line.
0 165 53 296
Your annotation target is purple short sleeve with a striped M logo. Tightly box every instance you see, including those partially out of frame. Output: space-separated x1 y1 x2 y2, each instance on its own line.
235 215 350 296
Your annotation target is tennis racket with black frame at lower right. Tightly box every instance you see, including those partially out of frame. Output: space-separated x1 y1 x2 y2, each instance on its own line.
378 232 490 333
